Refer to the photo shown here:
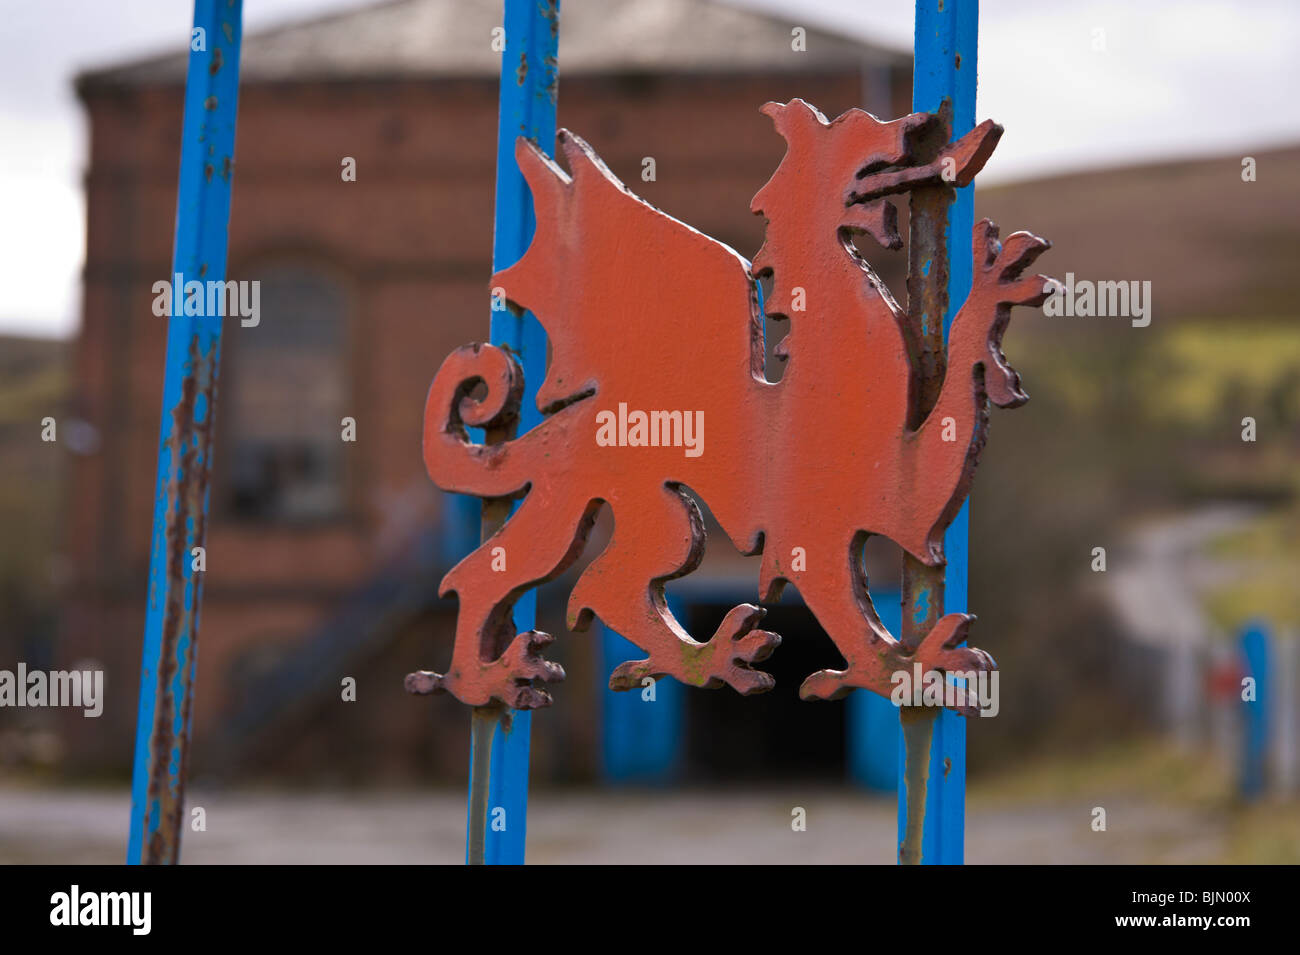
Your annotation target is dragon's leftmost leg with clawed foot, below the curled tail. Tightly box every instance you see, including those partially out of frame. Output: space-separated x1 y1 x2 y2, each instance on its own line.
407 498 599 709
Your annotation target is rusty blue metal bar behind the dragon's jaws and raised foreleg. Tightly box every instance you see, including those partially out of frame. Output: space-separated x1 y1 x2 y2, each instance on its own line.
898 0 979 864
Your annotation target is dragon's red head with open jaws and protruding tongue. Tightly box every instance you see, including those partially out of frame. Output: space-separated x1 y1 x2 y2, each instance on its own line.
750 99 1002 275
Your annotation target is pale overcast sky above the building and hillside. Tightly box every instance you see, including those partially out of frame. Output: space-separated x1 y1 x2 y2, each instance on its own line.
0 0 1300 335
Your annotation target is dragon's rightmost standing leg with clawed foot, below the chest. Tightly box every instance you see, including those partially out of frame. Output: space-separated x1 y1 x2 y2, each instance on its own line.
783 534 997 709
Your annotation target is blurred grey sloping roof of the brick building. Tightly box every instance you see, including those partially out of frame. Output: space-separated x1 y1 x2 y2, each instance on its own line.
74 0 911 100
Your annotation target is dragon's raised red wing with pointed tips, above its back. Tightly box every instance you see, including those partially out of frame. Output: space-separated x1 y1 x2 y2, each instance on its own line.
491 130 763 409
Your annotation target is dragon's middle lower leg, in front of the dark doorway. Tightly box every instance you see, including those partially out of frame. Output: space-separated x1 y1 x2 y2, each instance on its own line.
568 487 781 695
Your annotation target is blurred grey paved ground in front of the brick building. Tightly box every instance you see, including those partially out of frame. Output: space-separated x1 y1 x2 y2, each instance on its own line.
0 787 1223 864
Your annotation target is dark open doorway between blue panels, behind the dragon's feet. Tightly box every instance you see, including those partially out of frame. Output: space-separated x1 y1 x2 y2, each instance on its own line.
684 594 845 783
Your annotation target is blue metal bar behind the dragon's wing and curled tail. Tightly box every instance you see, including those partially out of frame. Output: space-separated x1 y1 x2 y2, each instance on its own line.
467 0 560 865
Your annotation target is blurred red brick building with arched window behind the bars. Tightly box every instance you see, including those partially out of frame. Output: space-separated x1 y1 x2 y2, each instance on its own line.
61 0 910 778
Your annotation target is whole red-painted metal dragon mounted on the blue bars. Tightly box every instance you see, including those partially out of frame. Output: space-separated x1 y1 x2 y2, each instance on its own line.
407 99 1052 709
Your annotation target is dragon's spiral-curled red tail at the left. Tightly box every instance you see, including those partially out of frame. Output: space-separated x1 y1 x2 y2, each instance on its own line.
424 343 528 498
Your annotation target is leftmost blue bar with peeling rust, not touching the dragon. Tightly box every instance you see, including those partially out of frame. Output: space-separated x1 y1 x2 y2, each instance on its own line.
126 0 243 864
